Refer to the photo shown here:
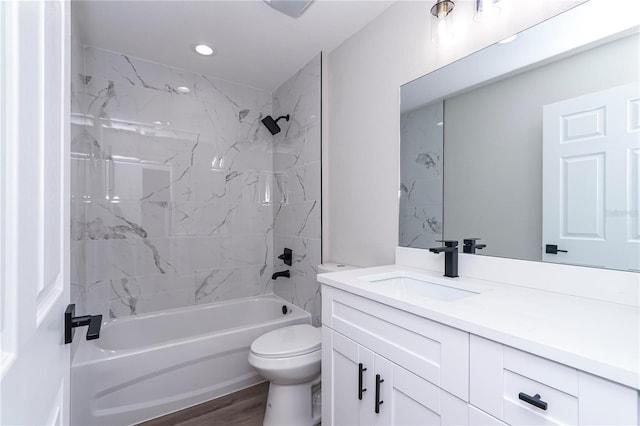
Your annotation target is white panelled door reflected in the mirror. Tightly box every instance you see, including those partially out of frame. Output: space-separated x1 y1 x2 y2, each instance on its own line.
542 83 640 271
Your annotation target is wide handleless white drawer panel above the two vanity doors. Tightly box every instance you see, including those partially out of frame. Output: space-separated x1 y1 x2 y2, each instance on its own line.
322 287 469 401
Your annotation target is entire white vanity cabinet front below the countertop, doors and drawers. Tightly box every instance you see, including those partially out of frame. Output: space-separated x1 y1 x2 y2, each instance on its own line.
322 286 640 426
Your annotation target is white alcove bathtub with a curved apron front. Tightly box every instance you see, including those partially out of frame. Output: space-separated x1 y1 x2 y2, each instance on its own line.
71 295 311 426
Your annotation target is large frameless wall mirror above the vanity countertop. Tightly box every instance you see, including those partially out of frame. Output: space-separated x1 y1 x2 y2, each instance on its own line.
399 3 640 272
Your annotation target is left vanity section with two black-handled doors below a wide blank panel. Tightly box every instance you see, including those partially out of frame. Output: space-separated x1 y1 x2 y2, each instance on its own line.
322 287 469 425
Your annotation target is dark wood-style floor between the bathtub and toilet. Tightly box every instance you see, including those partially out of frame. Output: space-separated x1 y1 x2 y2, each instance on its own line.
139 382 269 426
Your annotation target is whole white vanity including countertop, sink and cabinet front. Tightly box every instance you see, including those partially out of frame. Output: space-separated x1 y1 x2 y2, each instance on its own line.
318 248 640 425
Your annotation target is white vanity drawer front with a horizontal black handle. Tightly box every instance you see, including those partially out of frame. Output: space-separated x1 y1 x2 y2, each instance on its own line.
469 335 638 425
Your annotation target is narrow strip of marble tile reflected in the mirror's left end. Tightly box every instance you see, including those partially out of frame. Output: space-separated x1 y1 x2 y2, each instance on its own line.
399 102 444 248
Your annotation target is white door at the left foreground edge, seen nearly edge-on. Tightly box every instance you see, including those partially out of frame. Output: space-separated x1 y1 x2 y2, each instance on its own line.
0 0 69 425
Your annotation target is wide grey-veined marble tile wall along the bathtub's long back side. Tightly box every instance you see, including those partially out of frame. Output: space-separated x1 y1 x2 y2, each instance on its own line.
71 48 276 318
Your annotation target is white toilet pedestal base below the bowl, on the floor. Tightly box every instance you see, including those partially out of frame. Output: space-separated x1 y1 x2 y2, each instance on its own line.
263 376 320 426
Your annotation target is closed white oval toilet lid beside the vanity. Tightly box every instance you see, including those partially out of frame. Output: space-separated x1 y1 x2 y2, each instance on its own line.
251 324 322 358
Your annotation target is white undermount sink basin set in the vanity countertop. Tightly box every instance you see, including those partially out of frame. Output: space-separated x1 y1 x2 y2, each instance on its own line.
360 272 480 301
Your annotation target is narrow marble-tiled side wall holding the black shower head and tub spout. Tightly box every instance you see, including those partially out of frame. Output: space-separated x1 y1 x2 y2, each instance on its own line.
273 54 322 326
